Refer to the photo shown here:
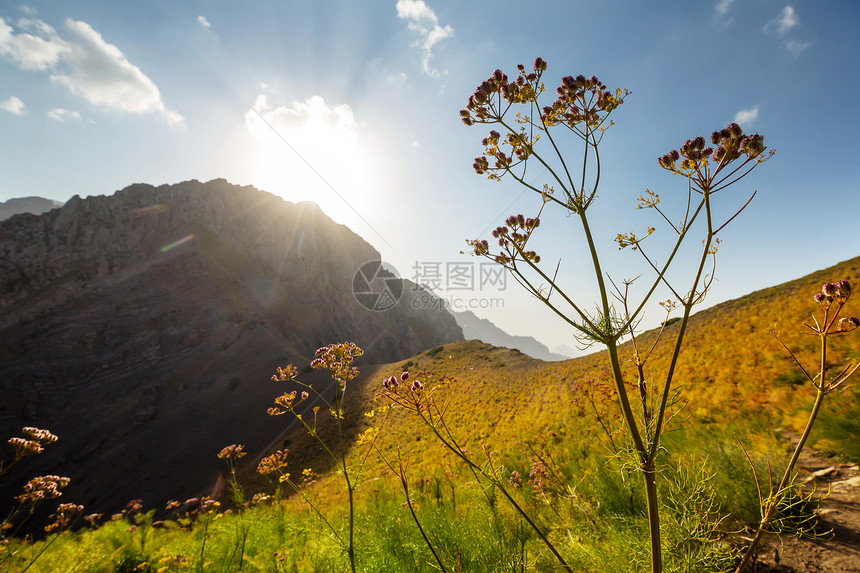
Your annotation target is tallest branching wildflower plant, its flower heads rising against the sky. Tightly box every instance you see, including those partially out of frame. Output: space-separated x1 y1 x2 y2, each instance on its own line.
460 58 770 573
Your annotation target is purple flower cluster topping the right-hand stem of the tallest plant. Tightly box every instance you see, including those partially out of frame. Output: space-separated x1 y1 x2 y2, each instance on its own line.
657 123 765 175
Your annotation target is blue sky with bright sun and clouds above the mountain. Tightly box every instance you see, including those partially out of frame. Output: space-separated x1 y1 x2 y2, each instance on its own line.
0 0 860 356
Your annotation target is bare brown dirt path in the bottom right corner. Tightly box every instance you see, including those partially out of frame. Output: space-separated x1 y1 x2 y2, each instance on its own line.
756 442 860 573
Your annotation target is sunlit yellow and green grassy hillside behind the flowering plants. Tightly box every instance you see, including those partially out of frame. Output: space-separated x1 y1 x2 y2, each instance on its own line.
6 258 860 572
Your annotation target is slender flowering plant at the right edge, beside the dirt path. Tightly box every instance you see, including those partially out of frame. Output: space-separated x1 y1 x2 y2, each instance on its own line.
737 280 860 573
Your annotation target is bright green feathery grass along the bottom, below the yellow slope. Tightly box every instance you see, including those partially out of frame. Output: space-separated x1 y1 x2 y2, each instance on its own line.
0 418 779 573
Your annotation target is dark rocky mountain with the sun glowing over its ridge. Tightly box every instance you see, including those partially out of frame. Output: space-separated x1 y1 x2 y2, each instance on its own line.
0 180 462 511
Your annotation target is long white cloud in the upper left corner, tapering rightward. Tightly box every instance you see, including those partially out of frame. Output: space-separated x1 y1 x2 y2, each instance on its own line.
0 18 184 125
